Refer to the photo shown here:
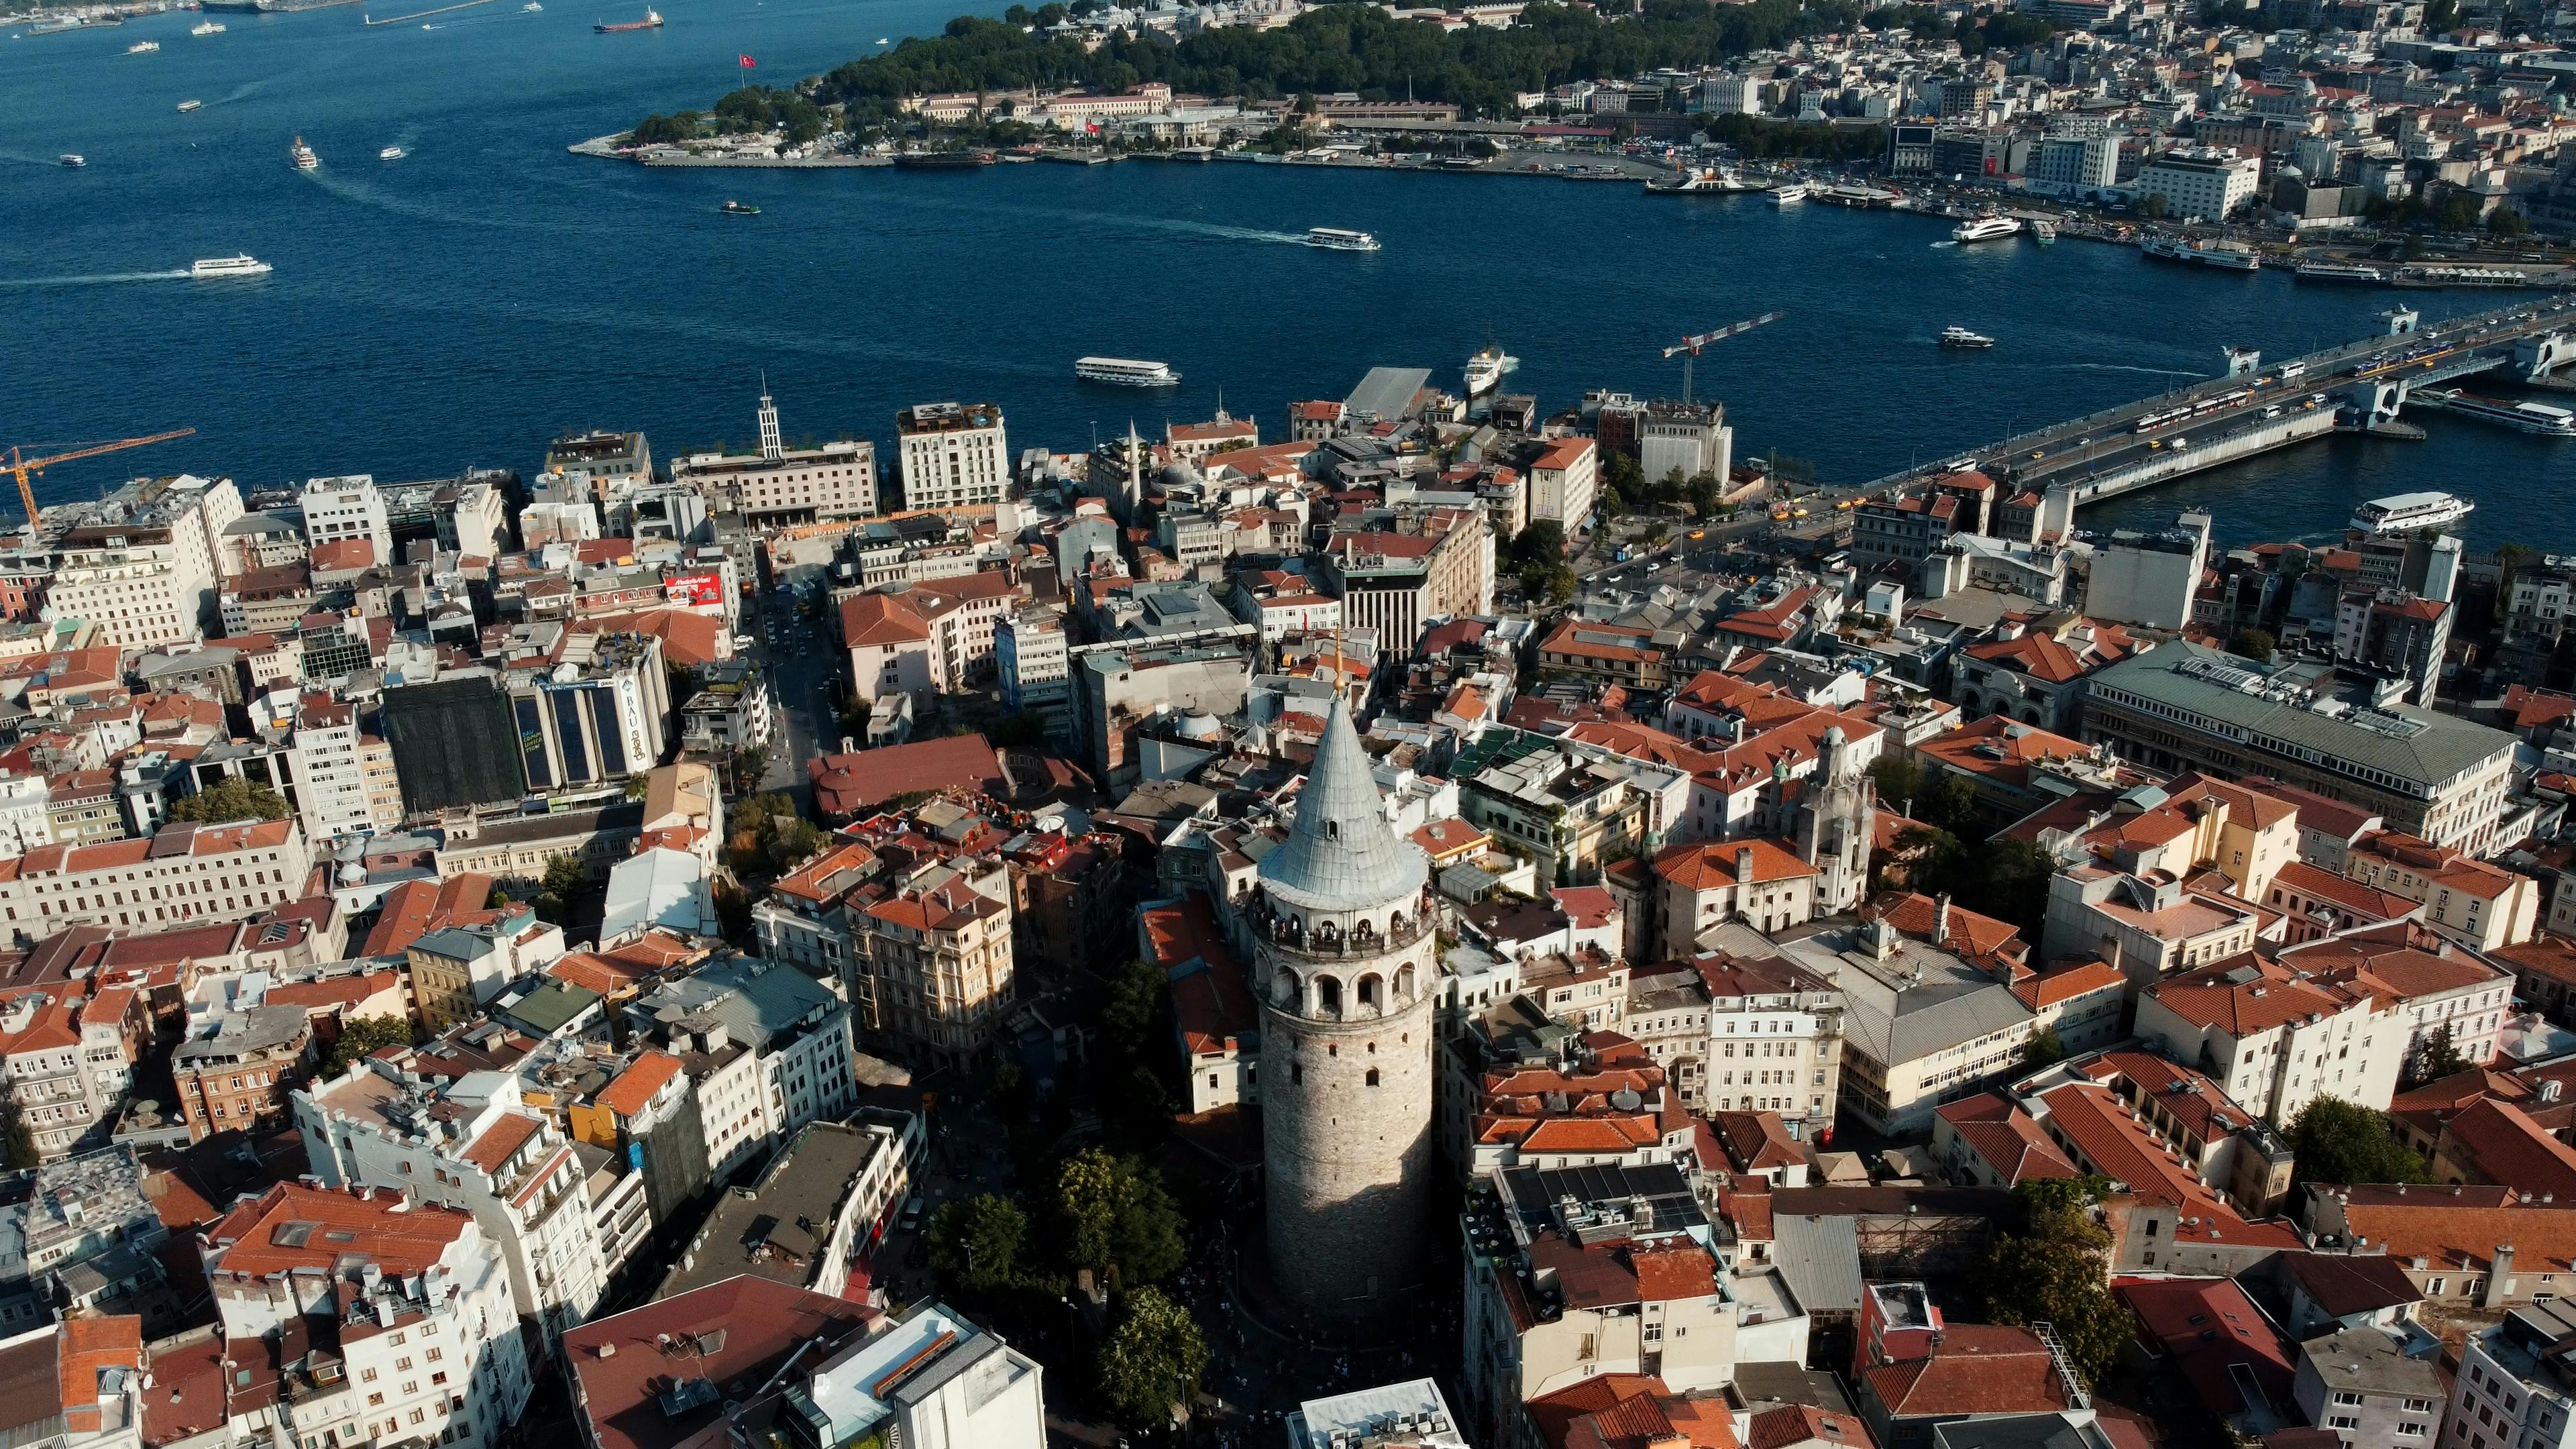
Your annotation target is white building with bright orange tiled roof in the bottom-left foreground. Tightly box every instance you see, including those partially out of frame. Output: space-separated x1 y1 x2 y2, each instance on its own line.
203 1183 531 1449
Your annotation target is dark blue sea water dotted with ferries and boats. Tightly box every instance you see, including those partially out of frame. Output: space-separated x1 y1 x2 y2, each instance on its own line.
0 0 2576 547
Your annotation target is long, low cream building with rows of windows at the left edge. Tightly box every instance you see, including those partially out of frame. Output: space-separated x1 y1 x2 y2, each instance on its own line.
0 820 312 938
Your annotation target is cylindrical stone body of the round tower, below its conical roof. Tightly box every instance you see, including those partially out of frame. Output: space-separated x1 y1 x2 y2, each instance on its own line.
1254 930 1438 1315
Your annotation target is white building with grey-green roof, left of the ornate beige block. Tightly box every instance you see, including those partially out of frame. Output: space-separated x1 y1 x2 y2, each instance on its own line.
626 957 858 1181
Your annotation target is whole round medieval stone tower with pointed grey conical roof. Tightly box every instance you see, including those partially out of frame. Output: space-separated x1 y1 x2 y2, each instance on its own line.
1249 699 1440 1312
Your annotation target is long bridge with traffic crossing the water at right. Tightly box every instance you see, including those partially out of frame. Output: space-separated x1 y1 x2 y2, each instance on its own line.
1862 297 2576 513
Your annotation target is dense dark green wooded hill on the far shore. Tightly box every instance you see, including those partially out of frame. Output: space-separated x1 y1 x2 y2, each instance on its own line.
812 0 1860 116
